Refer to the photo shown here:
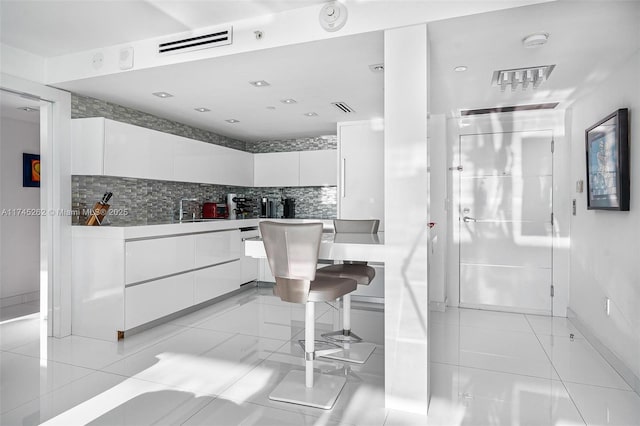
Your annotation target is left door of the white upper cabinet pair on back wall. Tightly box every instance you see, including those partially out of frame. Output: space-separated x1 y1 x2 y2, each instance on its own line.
253 152 300 187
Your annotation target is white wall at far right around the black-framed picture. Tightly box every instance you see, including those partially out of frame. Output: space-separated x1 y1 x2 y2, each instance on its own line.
569 51 640 384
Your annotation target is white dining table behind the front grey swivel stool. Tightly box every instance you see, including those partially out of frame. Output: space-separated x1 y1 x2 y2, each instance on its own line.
245 232 385 262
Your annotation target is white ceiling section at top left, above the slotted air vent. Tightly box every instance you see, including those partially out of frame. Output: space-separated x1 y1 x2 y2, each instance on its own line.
0 0 326 57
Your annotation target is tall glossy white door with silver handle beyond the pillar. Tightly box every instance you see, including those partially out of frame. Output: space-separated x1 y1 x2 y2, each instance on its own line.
459 131 553 314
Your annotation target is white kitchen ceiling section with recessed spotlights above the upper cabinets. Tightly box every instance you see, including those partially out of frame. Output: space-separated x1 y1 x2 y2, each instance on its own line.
58 32 384 141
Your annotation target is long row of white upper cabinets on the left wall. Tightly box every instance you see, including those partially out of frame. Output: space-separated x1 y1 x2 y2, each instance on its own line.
72 117 253 186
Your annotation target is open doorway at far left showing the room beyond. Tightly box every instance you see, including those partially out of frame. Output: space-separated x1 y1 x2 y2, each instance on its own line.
0 90 47 322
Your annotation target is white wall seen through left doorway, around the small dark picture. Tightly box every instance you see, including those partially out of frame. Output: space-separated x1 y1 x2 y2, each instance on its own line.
0 117 40 306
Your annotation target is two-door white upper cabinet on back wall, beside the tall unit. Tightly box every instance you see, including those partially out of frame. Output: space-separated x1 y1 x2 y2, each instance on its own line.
253 149 338 187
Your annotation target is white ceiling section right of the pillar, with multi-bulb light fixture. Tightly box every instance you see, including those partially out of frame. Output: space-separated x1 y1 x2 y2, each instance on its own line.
429 1 640 116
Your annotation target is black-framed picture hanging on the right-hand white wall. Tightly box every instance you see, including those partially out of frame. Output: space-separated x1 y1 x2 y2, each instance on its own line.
585 108 630 211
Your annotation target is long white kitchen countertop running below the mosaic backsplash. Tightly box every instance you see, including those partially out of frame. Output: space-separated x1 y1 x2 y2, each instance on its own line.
71 218 333 240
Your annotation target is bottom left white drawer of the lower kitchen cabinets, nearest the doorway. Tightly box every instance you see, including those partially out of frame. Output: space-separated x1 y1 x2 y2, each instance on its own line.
124 272 195 330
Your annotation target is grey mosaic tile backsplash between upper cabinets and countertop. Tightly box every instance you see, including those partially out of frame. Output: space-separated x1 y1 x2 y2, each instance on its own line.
71 176 337 226
